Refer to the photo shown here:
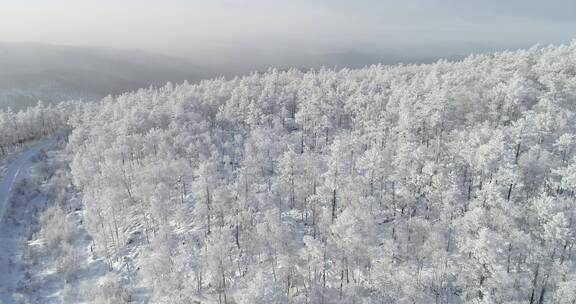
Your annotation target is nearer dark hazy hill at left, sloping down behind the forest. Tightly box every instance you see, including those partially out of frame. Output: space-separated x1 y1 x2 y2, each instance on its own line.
0 43 218 109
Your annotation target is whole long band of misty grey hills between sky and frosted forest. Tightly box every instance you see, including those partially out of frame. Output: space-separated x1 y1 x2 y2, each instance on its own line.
0 43 536 110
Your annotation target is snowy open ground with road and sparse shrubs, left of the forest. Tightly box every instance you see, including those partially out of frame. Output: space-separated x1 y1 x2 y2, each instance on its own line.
0 139 105 304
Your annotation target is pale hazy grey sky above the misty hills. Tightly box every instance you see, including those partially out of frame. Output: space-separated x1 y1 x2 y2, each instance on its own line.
0 0 576 61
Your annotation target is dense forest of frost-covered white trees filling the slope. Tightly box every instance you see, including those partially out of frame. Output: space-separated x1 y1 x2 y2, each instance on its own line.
0 43 576 304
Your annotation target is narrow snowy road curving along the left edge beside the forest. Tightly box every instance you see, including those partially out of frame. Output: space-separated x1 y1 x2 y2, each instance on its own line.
0 139 56 226
